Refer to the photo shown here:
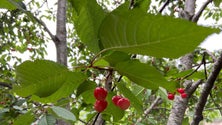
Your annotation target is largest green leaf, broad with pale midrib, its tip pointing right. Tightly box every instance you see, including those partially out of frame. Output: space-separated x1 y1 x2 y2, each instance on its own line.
99 7 219 58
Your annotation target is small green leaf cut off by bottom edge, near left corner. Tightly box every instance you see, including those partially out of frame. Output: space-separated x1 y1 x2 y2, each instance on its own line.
13 112 35 125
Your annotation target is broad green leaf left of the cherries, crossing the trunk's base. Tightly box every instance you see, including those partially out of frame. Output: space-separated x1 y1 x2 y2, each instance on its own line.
13 60 86 103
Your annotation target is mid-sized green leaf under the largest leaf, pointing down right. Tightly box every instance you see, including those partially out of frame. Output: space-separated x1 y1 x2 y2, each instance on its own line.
114 60 176 91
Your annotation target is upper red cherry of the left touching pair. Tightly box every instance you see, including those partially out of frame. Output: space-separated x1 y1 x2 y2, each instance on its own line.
94 87 107 100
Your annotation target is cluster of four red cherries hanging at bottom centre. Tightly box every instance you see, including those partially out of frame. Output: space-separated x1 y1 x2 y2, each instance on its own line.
94 87 130 112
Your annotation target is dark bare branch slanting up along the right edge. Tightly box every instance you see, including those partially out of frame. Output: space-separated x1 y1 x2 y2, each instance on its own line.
191 53 222 125
